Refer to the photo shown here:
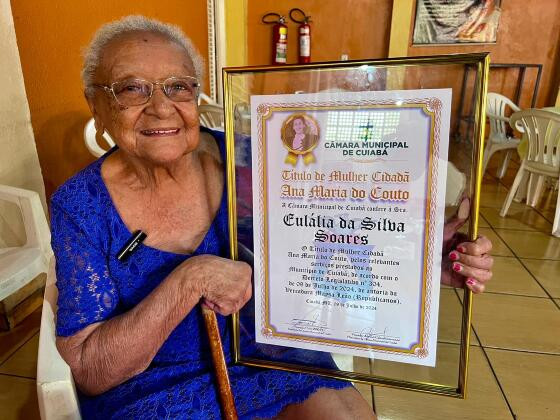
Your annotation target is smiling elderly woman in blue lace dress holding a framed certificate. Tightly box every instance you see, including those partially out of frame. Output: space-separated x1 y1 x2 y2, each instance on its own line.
52 16 491 419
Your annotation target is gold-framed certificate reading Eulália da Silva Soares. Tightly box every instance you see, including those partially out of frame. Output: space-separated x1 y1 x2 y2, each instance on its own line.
224 54 488 397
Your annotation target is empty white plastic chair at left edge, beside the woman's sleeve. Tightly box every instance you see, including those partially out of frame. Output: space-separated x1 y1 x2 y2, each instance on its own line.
0 185 53 300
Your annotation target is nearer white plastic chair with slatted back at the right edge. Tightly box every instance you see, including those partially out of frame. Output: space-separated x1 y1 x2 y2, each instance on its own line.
500 109 560 237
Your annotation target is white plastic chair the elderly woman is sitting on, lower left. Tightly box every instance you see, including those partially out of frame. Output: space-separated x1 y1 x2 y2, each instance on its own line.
37 258 81 420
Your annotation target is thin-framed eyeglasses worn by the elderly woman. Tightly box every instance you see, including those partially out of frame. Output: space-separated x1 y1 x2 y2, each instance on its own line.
93 76 200 106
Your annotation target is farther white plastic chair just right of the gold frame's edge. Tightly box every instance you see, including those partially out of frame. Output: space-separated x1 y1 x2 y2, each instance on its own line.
482 92 519 178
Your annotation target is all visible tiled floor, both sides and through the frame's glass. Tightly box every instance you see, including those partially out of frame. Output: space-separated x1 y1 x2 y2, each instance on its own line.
0 156 560 420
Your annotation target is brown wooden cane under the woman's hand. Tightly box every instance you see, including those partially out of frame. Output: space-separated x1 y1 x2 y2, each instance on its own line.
202 305 237 420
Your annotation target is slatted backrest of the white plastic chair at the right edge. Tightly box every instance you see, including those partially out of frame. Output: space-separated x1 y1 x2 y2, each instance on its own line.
510 108 560 169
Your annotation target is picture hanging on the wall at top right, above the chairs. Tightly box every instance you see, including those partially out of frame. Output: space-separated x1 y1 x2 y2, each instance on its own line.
412 0 502 45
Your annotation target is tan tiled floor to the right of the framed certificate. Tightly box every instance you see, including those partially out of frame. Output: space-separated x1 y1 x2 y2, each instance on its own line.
372 155 560 420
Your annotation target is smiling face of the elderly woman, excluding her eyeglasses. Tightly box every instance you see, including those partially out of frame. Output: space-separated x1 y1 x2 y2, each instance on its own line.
88 32 199 165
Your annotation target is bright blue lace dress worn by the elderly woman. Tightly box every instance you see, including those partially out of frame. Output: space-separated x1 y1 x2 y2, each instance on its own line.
51 132 349 419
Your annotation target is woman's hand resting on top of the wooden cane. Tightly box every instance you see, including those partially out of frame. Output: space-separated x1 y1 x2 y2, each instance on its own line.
181 255 252 315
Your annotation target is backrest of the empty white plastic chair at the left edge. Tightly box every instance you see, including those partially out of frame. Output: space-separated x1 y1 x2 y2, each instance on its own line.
0 185 52 261
